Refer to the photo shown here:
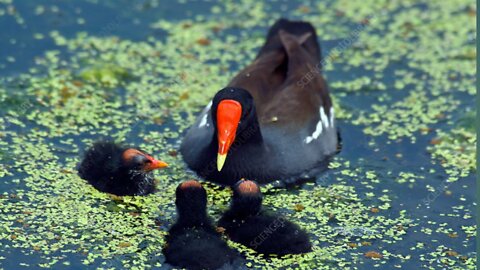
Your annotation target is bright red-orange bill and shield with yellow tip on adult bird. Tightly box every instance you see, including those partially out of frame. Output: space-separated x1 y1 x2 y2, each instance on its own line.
217 99 242 171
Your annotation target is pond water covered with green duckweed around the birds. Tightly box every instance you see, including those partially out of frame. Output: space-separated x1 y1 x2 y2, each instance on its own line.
0 0 476 269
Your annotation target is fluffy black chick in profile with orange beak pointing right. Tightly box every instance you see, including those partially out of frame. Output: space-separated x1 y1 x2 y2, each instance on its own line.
78 142 168 196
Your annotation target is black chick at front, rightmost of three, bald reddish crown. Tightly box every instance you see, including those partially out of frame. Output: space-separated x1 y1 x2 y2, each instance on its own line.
218 180 312 255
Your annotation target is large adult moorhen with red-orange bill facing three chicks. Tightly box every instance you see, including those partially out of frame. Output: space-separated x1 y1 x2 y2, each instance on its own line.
180 19 339 185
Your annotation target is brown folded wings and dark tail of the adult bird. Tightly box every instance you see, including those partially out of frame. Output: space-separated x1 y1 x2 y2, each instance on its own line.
229 19 331 129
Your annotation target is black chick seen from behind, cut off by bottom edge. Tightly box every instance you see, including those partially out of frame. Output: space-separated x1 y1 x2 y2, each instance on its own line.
163 180 240 269
